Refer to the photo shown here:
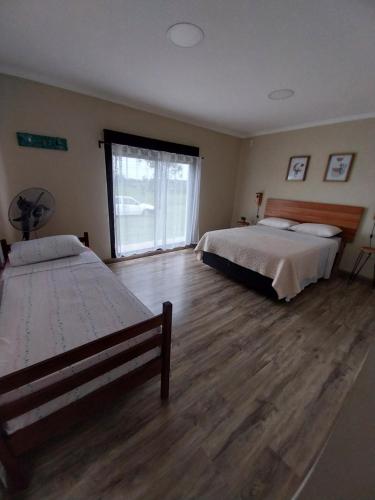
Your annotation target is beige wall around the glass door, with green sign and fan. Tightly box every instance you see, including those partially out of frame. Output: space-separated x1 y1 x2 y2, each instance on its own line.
0 75 240 258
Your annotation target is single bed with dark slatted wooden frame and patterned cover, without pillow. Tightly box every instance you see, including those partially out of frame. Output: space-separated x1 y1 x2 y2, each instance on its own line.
0 235 172 489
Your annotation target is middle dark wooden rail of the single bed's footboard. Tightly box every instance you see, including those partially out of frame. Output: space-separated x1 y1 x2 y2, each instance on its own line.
0 334 162 422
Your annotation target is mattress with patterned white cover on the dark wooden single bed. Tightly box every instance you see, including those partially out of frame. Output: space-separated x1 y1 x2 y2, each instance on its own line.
0 250 160 433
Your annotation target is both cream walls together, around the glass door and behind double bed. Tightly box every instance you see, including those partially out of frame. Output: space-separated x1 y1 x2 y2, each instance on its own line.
0 75 375 274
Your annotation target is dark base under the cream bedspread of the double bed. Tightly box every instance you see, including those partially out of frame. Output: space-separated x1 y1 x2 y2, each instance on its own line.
203 252 278 300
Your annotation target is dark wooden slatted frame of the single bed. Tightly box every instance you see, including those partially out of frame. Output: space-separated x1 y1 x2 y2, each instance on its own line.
0 233 172 491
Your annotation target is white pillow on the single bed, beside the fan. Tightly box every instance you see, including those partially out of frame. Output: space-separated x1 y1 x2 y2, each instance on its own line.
9 235 86 266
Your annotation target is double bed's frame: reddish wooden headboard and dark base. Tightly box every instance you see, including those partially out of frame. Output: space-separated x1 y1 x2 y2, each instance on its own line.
203 198 364 300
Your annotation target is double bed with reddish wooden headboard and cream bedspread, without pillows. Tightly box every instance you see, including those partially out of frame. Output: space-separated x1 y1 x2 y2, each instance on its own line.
195 199 364 300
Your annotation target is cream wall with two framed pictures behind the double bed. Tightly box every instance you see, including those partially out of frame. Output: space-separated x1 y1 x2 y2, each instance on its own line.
232 119 375 275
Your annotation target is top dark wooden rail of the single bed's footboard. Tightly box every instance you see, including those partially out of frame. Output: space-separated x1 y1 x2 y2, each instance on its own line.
0 314 163 394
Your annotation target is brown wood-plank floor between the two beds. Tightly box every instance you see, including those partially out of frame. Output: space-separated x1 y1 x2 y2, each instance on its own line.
6 251 375 500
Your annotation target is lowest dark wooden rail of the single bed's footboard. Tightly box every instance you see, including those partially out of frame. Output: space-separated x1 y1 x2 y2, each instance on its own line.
6 356 162 456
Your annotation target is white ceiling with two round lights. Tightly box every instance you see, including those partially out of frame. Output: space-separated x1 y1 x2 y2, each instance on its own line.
0 0 375 137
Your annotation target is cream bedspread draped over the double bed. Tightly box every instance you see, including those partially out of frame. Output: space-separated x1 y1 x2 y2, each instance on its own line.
195 225 340 300
